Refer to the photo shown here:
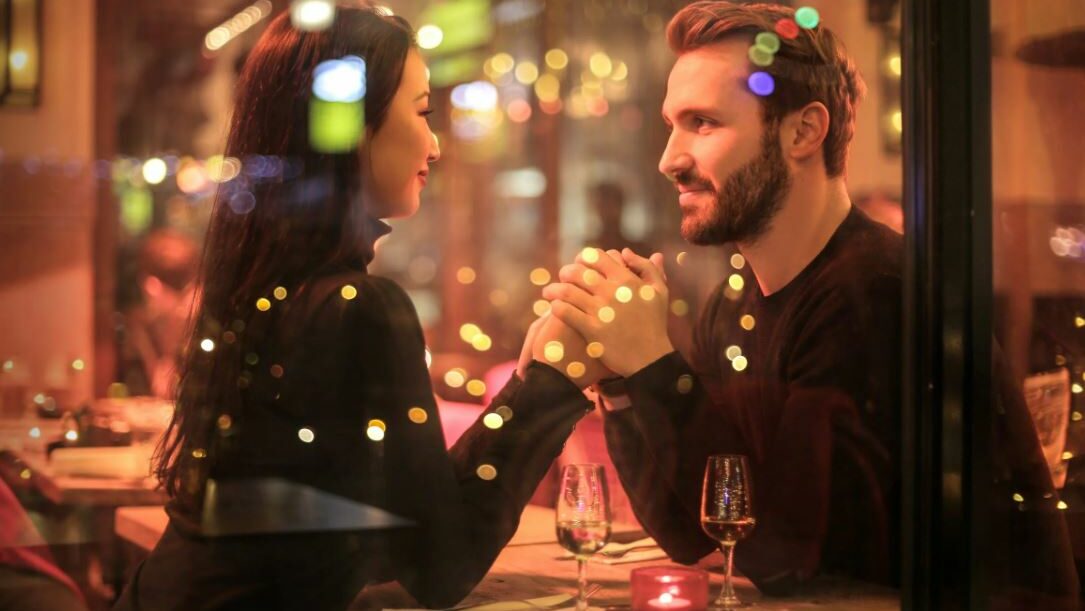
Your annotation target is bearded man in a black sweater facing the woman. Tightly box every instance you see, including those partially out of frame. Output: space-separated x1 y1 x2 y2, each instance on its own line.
536 1 902 591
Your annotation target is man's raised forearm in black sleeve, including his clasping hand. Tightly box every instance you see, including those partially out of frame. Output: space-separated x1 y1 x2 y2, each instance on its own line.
544 249 718 563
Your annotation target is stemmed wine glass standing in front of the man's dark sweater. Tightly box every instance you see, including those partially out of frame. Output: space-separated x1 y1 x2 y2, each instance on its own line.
701 454 756 609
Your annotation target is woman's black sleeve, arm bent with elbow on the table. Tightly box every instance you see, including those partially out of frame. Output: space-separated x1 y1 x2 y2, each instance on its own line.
347 277 591 607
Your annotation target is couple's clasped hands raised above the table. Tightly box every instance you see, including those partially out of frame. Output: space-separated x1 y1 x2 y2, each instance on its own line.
518 247 674 389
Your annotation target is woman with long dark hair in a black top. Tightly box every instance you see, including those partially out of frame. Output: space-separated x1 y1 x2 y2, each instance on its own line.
117 8 591 609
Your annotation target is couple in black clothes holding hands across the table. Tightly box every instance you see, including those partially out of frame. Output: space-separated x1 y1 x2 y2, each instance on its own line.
117 0 1067 609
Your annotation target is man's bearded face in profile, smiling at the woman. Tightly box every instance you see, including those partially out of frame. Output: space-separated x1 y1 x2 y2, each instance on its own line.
660 39 790 245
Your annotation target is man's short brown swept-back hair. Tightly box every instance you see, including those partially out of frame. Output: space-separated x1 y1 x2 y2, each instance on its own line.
667 0 866 178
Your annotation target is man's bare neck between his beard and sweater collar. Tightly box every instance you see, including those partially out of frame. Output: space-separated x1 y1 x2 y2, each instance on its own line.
738 175 852 296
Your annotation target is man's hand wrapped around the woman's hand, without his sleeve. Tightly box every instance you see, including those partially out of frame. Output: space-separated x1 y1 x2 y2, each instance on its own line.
536 249 674 377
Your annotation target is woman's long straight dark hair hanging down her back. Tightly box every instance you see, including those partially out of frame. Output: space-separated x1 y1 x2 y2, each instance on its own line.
155 7 417 507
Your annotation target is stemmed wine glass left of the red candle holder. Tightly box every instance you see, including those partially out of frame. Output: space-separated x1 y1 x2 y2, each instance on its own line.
557 464 611 611
